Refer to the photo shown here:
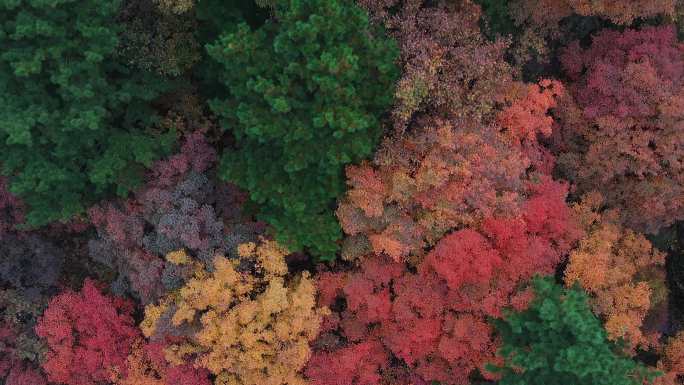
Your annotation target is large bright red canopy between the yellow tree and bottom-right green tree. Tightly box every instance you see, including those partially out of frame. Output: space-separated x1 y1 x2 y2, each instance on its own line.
307 177 581 385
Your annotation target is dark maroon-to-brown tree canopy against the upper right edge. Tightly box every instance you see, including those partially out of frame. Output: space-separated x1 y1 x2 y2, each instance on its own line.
556 27 684 233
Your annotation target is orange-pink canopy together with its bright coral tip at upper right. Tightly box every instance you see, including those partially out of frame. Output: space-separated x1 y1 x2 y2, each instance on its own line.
337 81 563 260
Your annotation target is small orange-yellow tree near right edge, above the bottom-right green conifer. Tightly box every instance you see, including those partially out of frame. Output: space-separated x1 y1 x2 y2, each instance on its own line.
565 193 667 349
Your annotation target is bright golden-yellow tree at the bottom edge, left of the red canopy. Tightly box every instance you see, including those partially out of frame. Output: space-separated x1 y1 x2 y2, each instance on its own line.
141 240 327 385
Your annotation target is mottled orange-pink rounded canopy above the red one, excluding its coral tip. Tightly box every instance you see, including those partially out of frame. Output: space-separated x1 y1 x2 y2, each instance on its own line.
337 119 529 261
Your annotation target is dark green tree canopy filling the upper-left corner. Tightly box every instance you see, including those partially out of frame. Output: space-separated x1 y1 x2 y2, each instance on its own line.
0 0 170 226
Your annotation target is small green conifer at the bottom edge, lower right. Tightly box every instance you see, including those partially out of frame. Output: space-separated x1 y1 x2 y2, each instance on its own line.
492 277 657 385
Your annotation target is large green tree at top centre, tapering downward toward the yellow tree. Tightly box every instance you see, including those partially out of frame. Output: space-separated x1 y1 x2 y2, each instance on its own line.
207 0 398 259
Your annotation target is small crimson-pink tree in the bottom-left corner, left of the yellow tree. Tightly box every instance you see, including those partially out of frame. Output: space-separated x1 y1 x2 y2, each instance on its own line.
36 280 140 385
